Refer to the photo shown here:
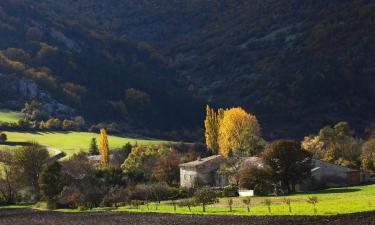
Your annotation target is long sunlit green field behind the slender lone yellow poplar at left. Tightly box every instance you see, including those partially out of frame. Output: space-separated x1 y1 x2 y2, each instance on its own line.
0 132 166 156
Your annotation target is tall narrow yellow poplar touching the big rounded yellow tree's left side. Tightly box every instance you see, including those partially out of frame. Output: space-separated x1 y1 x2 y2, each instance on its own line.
204 105 219 154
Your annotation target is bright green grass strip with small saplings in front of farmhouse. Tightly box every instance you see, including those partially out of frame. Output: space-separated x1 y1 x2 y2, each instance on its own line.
57 185 375 215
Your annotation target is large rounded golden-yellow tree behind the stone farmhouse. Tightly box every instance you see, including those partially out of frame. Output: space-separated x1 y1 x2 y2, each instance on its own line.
218 107 260 156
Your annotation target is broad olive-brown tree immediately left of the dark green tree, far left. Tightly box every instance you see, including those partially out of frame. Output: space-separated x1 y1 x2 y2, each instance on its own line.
11 143 49 200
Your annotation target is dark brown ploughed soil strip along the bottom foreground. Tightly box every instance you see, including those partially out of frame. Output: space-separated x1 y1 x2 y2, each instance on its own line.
0 209 375 225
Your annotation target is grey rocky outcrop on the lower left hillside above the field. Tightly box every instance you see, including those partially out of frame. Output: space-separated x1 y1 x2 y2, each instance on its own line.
0 74 75 118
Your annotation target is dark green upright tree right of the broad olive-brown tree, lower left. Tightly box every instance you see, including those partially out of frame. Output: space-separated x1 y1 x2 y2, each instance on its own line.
39 160 63 209
